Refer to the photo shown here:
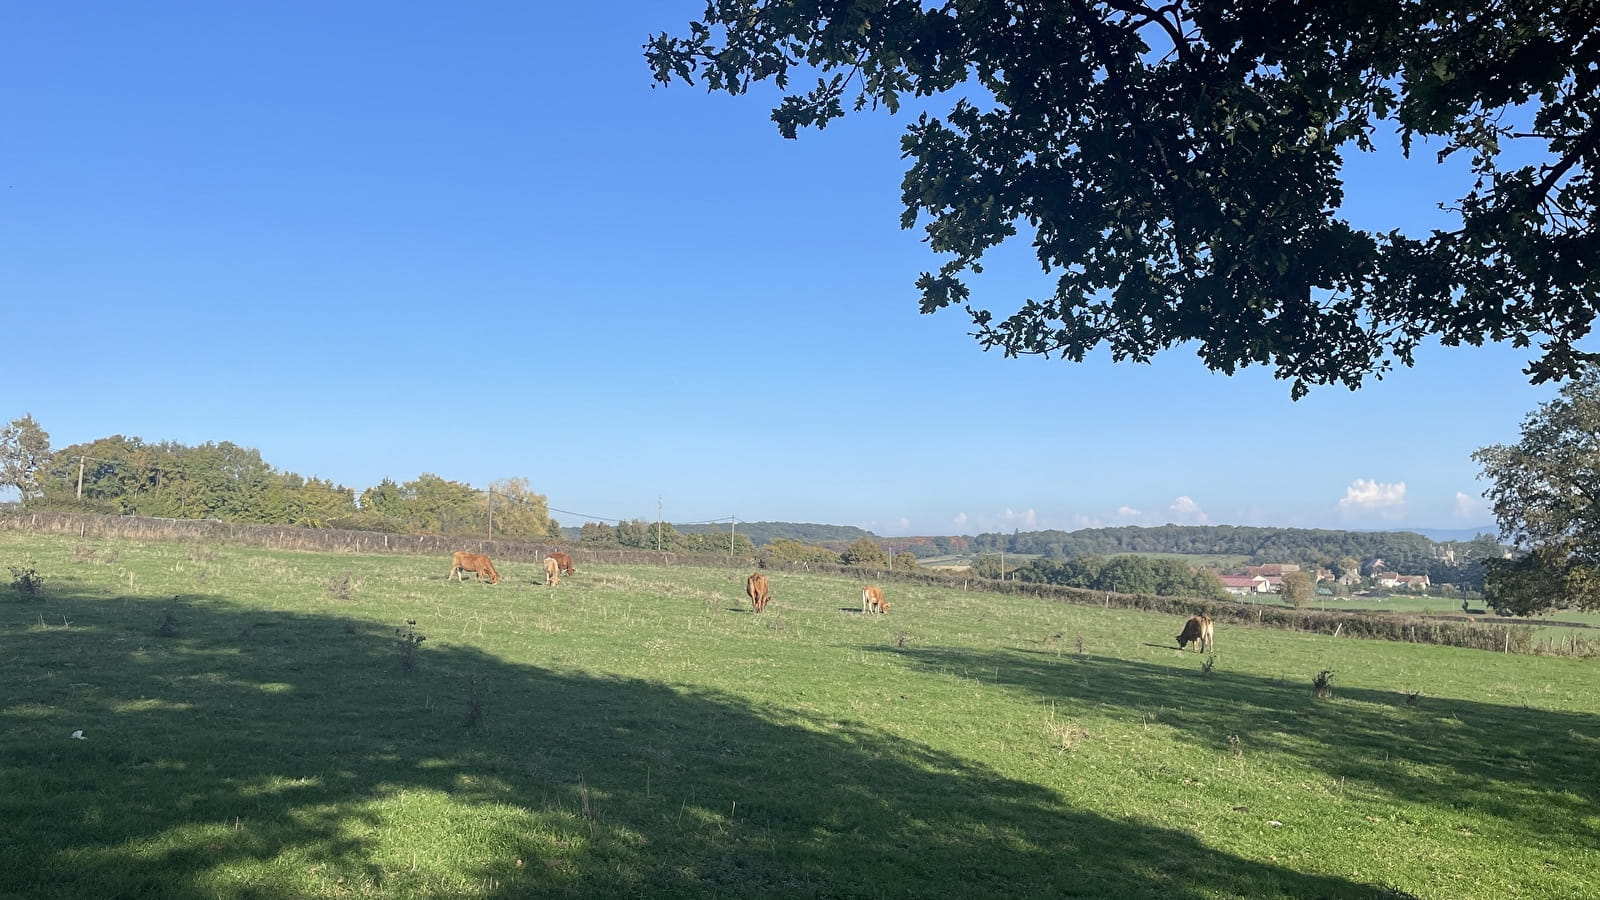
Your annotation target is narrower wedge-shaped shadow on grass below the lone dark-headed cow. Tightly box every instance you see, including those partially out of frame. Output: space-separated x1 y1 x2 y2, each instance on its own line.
877 647 1600 847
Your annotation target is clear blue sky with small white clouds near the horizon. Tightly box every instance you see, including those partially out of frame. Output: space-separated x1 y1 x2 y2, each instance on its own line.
0 0 1574 535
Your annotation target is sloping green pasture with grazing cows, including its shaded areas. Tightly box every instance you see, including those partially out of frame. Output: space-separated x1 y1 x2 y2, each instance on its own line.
0 533 1600 900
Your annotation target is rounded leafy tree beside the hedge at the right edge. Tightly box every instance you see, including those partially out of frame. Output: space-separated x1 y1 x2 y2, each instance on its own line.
1472 367 1600 613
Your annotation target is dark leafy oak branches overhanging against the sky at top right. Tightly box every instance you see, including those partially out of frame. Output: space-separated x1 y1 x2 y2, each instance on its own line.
645 0 1600 397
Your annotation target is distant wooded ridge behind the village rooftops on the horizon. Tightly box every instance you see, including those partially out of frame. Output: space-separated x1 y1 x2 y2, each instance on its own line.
973 525 1506 589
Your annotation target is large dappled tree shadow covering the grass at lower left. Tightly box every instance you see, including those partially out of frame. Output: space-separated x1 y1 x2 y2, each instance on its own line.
9 596 1414 900
